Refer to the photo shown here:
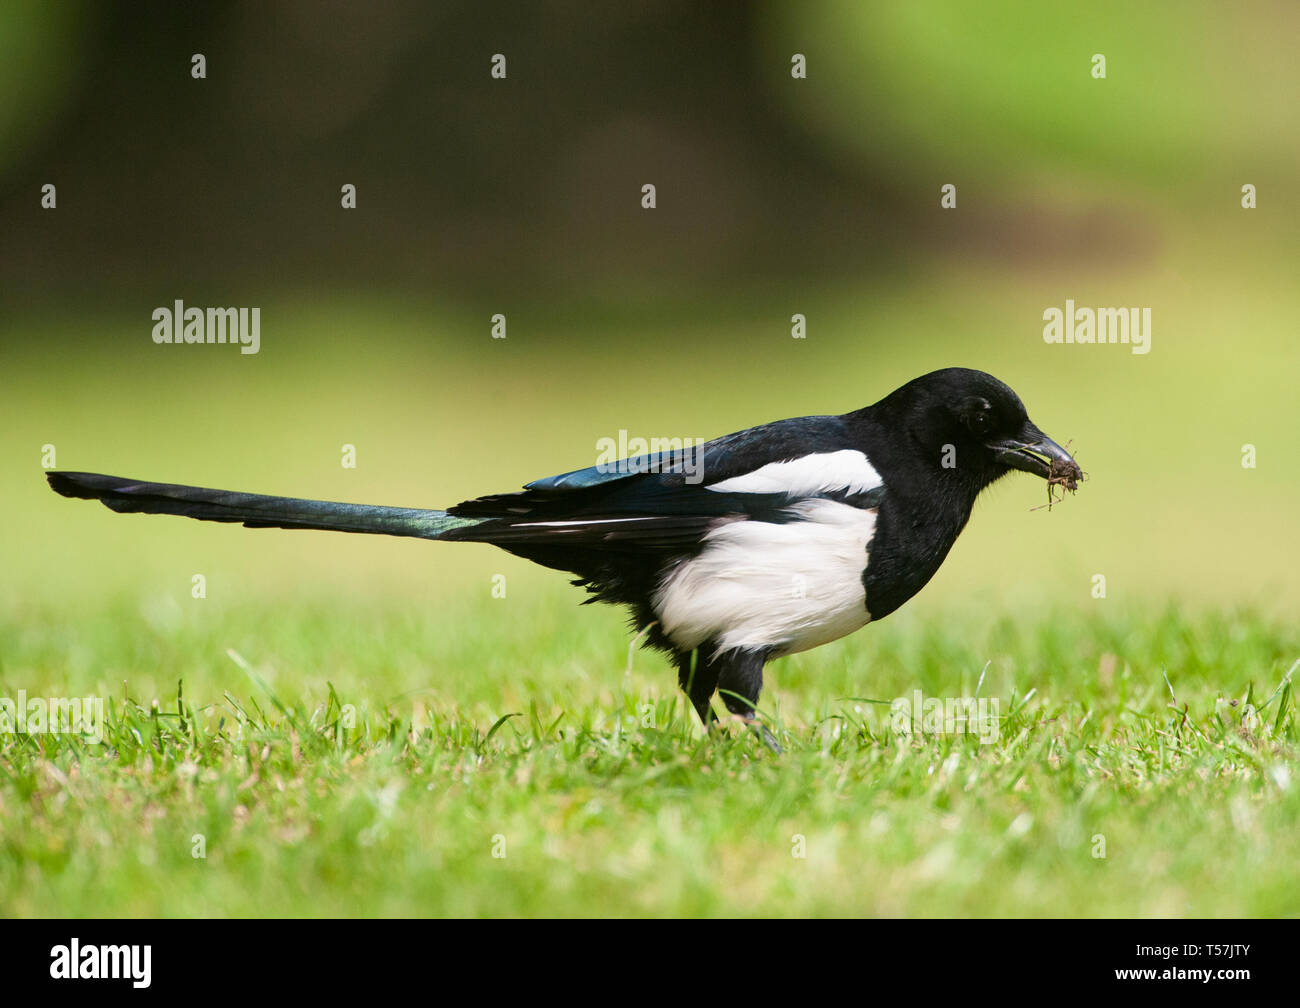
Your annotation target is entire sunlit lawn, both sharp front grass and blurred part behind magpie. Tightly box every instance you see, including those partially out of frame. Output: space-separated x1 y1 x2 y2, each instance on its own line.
0 270 1300 917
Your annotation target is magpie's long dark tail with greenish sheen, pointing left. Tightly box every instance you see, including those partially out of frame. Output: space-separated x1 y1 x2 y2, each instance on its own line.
46 472 484 538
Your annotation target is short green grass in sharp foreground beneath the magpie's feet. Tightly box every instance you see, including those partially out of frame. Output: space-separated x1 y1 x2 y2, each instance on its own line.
0 588 1300 917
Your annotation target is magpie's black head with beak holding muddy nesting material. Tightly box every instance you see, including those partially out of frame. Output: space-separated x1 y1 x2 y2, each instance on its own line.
880 368 1083 490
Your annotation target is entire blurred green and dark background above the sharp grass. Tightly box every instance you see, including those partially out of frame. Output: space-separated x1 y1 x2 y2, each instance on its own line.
0 0 1300 639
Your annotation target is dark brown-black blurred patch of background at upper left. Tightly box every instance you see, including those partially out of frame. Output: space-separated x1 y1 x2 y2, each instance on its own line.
4 3 932 300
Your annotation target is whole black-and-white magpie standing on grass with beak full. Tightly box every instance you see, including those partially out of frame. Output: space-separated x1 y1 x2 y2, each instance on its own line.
46 368 1083 739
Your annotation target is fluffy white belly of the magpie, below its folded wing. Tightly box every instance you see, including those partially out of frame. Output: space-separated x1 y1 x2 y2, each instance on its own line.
653 499 876 657
